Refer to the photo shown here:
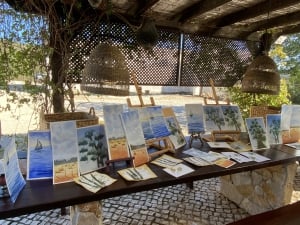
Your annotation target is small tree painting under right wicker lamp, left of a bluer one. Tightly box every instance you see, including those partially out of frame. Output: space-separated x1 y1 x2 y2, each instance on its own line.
246 117 270 150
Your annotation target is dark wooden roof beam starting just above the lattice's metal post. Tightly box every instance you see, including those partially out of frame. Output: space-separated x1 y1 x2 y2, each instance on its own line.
171 0 231 23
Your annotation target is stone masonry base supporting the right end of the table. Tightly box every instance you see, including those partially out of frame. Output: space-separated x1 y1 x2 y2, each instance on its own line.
220 163 297 215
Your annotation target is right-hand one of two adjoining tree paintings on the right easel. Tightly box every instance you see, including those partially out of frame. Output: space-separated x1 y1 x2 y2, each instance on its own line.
220 105 246 132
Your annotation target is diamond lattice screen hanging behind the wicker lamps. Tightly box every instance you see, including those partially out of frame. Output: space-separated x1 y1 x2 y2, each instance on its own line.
68 18 256 86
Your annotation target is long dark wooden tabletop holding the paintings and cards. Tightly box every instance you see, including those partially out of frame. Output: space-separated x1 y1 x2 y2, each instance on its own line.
0 145 300 219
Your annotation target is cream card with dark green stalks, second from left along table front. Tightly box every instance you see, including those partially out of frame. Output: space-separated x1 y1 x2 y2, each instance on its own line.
118 164 157 181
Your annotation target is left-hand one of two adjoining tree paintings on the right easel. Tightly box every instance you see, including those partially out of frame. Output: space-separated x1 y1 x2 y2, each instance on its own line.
203 105 225 130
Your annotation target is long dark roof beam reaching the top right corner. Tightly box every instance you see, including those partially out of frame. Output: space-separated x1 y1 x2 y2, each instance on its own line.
215 0 299 27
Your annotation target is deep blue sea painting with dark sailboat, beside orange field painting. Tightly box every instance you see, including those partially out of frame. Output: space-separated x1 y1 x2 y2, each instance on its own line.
27 130 53 180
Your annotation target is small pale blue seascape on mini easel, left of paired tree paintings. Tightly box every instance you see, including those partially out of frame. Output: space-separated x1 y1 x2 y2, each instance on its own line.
185 104 205 134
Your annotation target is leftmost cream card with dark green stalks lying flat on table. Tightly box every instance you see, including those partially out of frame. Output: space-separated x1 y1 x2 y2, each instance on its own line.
74 171 117 193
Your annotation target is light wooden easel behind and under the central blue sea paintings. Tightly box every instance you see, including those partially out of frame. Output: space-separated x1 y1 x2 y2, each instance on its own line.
127 74 175 158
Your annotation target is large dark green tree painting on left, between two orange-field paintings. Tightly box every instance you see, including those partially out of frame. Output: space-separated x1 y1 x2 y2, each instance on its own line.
77 125 108 174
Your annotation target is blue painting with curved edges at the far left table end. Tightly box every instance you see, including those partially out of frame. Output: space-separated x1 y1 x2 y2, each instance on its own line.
3 136 26 203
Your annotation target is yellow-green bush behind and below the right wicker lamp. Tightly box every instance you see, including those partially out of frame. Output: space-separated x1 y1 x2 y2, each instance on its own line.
227 79 291 118
